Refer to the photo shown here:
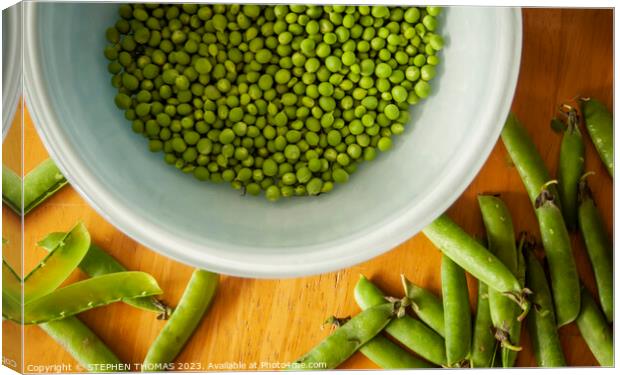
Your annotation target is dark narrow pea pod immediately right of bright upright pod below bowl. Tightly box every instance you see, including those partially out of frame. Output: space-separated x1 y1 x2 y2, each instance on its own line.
470 281 499 368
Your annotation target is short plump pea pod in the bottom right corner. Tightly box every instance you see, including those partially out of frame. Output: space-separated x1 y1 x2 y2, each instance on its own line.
577 288 614 367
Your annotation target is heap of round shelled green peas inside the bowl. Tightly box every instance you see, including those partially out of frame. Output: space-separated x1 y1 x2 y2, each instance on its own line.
104 4 443 201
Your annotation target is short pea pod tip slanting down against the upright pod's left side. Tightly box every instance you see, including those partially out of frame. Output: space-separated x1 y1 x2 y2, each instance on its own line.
401 275 445 337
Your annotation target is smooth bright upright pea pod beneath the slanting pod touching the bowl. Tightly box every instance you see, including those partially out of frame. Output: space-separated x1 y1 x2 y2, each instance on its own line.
441 255 471 367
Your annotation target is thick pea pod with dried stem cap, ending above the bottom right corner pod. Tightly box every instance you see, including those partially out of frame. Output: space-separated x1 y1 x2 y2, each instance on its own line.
536 189 580 327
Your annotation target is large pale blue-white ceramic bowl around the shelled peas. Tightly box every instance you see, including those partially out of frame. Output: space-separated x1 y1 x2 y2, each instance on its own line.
25 2 521 278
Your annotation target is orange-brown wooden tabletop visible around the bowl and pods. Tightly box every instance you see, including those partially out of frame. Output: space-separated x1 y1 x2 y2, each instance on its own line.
3 8 613 370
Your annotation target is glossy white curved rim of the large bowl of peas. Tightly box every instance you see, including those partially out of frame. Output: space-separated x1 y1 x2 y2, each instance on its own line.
24 3 522 278
